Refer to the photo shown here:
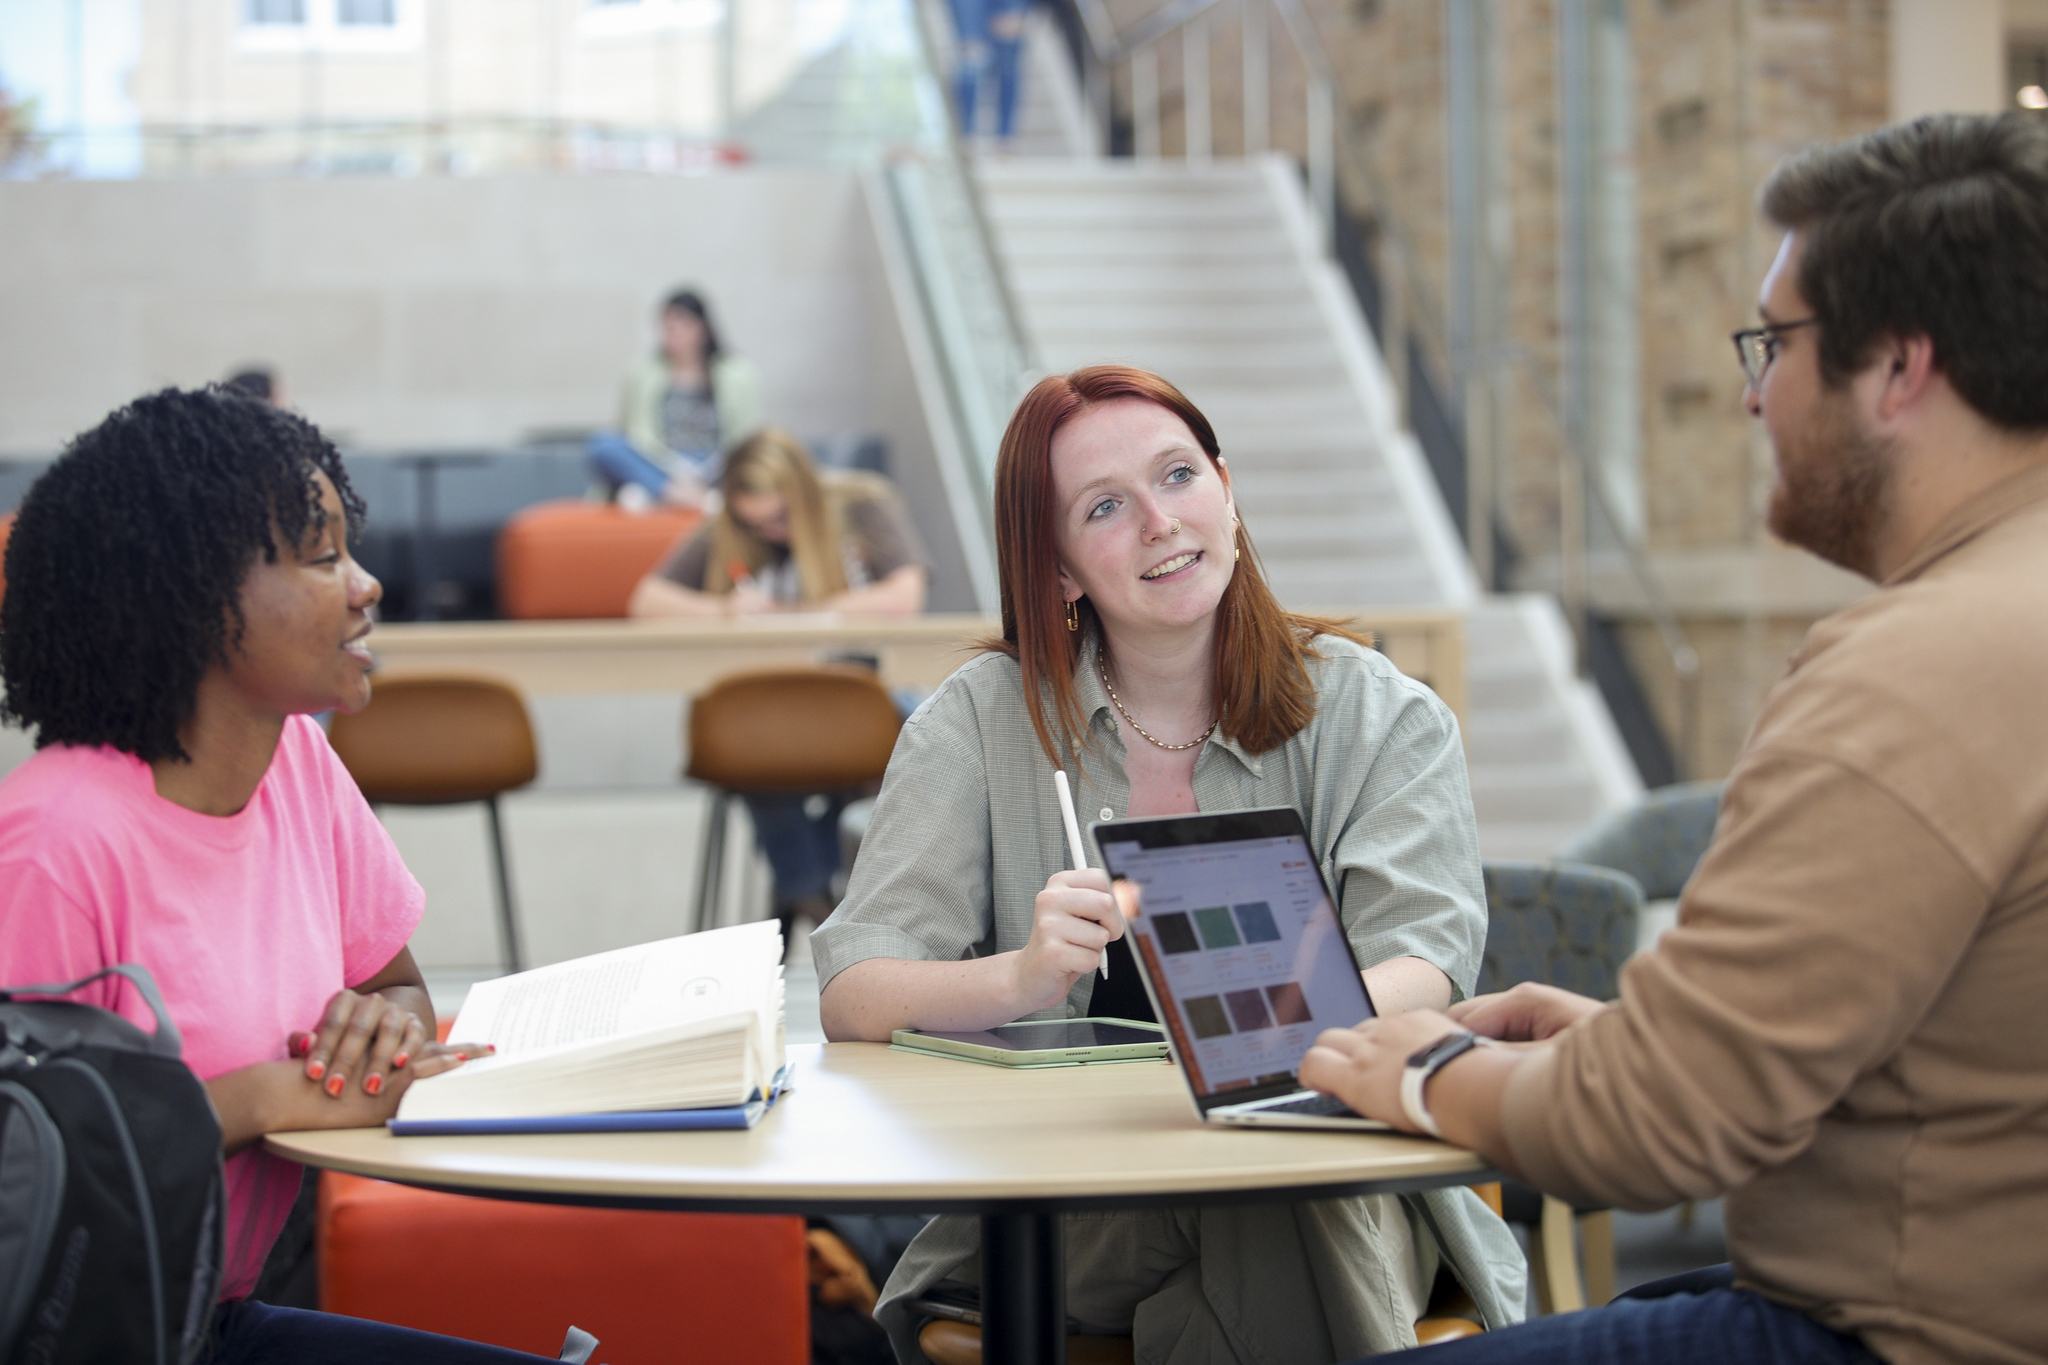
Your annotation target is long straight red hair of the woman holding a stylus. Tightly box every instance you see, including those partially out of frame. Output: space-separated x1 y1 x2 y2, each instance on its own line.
983 364 1366 767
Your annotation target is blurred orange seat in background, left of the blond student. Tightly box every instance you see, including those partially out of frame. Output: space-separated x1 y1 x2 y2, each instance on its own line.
498 499 702 620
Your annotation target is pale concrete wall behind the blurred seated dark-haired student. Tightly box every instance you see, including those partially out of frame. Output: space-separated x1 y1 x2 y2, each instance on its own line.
0 170 877 452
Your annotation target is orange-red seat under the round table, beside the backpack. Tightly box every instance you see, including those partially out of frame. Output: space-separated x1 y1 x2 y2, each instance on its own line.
317 1171 811 1365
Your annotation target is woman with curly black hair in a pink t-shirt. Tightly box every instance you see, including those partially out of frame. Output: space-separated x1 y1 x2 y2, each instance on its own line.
0 389 569 1365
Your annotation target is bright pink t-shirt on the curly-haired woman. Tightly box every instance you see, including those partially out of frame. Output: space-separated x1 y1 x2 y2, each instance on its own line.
0 716 424 1297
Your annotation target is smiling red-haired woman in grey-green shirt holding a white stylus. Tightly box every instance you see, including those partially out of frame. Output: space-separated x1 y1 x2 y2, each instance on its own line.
811 366 1524 1361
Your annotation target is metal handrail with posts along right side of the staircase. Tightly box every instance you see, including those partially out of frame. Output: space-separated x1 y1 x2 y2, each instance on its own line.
1073 0 1700 776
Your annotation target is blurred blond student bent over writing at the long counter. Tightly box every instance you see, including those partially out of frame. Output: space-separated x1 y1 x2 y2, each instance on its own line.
629 430 928 941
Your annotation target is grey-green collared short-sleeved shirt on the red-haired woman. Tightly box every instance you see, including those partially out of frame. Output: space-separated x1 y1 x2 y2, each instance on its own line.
811 636 1487 1002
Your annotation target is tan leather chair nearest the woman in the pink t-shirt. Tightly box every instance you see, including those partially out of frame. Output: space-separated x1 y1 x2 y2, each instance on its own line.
328 675 541 972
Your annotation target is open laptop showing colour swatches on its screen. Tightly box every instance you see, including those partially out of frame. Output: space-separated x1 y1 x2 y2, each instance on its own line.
1090 806 1386 1132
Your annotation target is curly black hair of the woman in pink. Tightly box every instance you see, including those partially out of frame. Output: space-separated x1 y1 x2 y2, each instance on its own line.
0 387 362 763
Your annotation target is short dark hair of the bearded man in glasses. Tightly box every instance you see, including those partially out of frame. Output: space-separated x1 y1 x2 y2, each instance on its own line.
1761 113 2048 430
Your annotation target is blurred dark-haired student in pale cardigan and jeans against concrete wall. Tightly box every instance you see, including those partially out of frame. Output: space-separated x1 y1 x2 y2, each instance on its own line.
590 289 760 508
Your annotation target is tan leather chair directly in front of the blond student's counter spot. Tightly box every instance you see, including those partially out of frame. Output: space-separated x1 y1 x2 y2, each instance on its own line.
684 663 903 929
